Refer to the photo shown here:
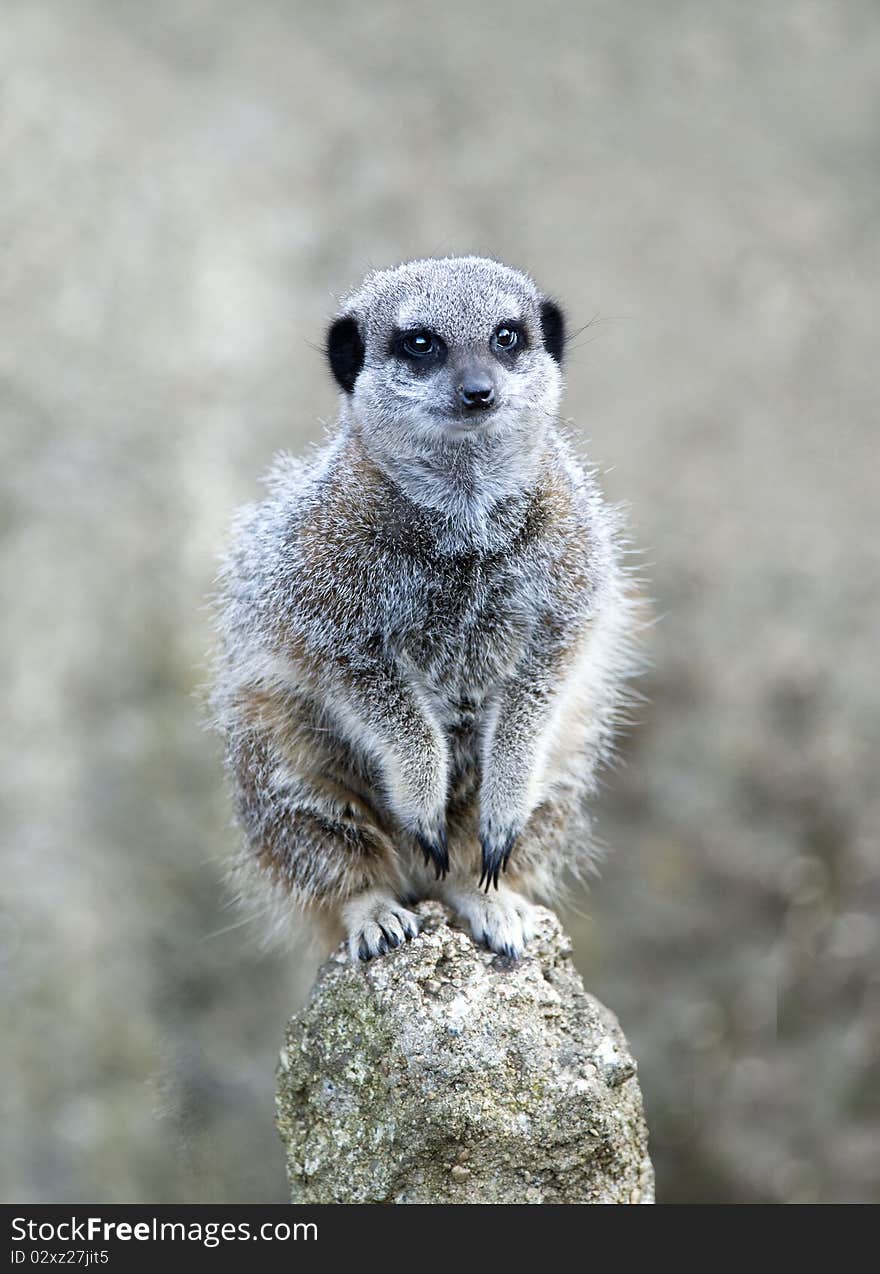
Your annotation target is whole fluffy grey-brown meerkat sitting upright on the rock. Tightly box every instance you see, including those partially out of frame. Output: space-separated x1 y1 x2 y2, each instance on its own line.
213 256 634 959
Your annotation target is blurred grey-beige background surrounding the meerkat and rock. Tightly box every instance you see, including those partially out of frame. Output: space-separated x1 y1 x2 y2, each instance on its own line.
0 0 880 1203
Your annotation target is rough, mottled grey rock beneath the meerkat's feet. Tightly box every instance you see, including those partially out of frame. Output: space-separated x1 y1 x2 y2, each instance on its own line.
278 903 653 1203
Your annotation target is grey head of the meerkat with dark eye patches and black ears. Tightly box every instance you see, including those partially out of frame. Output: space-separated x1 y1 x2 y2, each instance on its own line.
327 257 564 454
